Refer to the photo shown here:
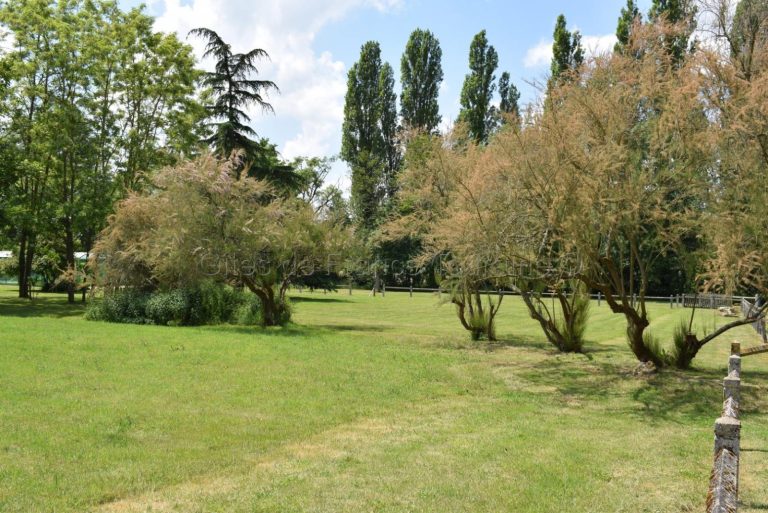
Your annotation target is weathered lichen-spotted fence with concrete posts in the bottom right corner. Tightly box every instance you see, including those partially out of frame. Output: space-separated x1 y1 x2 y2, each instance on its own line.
707 343 741 513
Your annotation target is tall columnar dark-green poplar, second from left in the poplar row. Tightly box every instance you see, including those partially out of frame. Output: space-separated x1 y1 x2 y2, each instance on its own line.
400 29 443 133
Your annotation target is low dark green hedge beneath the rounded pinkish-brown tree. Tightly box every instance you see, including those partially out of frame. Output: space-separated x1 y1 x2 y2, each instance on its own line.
85 283 261 326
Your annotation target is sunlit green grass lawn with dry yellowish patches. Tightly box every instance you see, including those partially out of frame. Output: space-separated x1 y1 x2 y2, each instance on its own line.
0 286 768 513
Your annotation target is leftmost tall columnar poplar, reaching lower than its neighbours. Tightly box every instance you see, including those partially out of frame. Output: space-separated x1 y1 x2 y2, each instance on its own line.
341 41 400 233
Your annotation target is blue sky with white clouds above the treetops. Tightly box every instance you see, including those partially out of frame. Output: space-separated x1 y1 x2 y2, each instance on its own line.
120 0 651 189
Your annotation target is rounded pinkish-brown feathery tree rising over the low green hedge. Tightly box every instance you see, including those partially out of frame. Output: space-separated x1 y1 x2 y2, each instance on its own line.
92 156 344 326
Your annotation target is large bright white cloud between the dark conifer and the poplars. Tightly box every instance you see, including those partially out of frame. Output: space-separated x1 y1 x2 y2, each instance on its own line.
150 0 403 184
